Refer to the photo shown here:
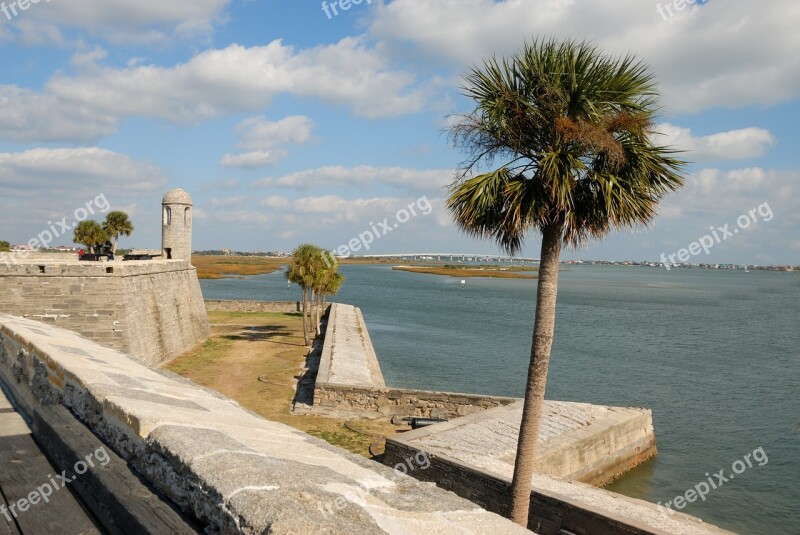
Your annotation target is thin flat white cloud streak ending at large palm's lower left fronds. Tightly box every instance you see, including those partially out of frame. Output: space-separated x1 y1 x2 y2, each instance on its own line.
253 165 454 195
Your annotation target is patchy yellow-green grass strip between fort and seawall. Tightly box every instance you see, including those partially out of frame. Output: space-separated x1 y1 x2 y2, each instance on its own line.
164 312 396 457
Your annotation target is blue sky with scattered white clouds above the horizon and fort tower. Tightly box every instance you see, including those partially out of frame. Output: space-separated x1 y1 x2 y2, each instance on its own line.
0 0 800 265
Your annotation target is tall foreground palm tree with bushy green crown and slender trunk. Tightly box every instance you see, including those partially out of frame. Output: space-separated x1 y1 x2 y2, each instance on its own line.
447 40 685 526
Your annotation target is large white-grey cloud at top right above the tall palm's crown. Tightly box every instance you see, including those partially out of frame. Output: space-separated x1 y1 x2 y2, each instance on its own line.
369 0 800 113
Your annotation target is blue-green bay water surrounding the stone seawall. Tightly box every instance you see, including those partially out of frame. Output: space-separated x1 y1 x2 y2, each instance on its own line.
201 265 800 534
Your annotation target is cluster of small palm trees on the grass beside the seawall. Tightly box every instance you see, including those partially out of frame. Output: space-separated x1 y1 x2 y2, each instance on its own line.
286 243 344 346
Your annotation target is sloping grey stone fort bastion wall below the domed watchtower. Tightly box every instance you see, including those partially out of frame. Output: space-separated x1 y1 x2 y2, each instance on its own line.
0 255 209 366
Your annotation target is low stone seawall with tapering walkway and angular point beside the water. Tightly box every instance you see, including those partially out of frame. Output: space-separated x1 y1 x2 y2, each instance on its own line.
314 304 730 535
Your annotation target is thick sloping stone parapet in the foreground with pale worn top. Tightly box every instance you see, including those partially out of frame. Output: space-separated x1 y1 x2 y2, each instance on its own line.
0 315 527 535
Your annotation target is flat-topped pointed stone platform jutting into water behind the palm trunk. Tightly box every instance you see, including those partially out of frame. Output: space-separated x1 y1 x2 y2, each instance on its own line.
387 400 656 486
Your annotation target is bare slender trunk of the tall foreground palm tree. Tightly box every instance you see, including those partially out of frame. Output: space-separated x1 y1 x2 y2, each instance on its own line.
510 223 562 527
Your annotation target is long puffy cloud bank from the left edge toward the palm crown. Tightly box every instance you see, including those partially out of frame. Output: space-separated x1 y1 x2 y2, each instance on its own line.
0 38 427 141
